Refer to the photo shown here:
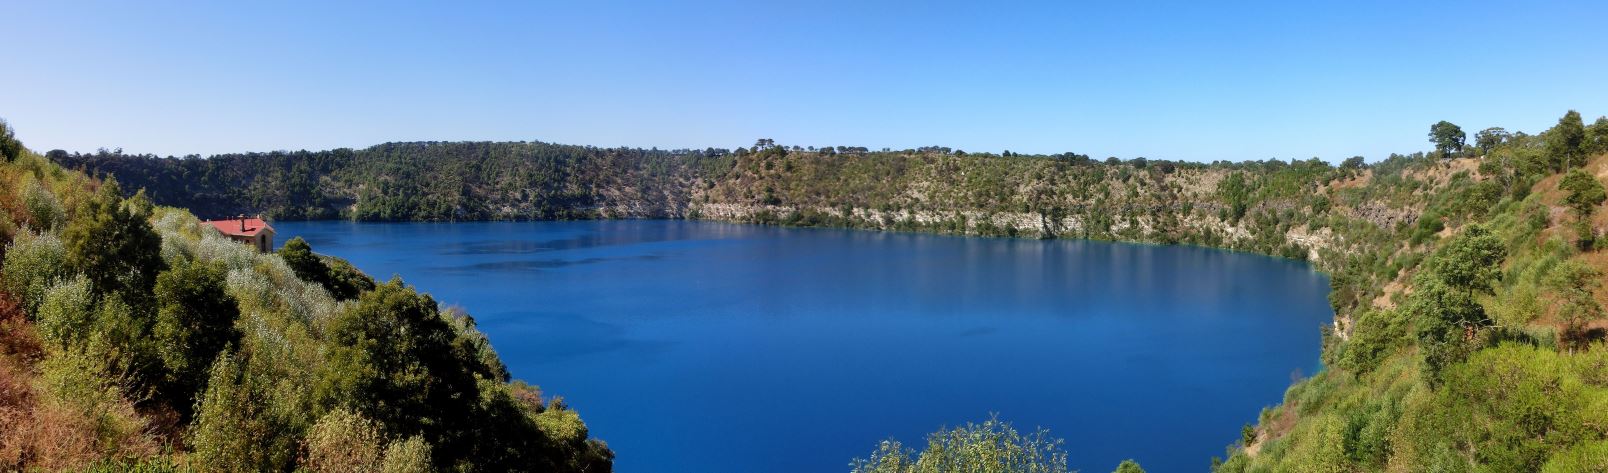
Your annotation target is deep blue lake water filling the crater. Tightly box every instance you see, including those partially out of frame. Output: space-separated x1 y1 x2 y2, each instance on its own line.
277 220 1330 473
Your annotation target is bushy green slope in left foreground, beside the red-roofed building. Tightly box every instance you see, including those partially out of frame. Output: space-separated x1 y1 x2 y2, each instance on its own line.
0 122 613 471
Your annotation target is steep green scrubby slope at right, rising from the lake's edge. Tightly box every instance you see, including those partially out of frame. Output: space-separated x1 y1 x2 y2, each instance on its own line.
1216 111 1608 471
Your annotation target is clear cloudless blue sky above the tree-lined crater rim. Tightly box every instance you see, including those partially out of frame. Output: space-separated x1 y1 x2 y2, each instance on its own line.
0 0 1608 161
